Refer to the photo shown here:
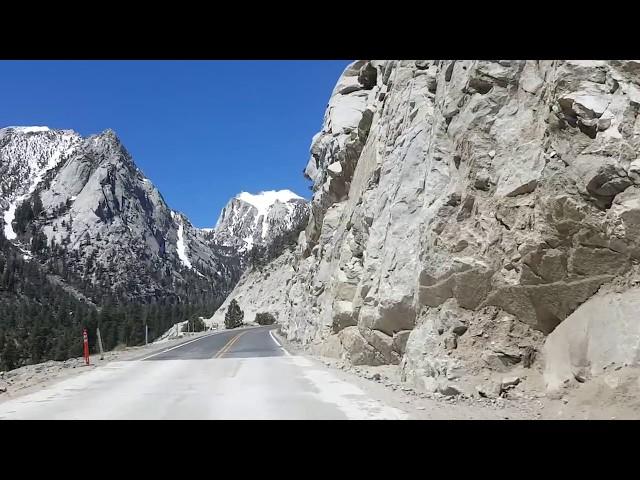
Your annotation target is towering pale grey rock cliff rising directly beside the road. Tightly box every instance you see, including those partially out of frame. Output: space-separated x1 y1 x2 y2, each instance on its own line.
218 60 640 390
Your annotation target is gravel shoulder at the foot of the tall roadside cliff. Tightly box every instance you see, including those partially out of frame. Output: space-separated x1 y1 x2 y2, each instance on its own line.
274 331 640 420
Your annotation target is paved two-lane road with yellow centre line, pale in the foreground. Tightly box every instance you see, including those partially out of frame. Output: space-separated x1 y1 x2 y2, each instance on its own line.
0 327 406 419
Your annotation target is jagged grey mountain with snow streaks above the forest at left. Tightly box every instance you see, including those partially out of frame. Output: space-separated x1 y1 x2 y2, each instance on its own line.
0 127 241 303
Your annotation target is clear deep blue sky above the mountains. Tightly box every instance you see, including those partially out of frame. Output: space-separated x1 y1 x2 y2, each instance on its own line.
0 60 349 227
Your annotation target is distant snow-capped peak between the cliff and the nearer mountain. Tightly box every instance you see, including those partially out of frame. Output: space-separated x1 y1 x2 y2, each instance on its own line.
209 190 309 254
